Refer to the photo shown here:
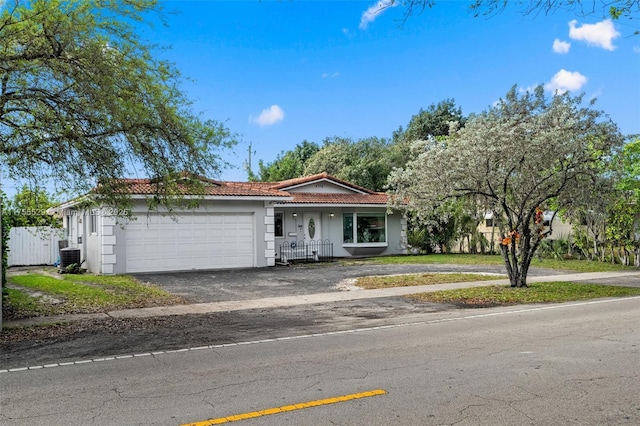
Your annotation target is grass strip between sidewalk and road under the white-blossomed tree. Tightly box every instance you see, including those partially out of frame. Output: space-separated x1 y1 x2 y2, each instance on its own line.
407 281 640 308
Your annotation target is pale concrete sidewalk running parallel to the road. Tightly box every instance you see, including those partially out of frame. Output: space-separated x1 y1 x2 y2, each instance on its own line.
4 271 640 328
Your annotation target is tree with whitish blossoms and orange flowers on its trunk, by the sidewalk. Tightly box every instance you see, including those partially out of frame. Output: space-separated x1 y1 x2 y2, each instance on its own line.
389 86 623 287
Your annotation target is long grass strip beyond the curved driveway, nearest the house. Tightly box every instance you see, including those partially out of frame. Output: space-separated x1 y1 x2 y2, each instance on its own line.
344 253 635 272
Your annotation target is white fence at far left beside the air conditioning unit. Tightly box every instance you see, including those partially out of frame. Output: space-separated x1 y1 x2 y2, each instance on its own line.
9 226 64 266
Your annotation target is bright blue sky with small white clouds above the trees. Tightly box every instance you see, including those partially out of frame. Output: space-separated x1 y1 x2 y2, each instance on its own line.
1 0 640 193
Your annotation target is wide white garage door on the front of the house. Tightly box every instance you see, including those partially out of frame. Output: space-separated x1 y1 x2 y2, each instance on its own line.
125 213 255 272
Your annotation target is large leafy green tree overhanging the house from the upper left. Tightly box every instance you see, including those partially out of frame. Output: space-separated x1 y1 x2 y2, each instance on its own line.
0 0 235 211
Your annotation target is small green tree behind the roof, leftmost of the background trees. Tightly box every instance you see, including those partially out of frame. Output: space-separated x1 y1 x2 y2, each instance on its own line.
256 140 320 182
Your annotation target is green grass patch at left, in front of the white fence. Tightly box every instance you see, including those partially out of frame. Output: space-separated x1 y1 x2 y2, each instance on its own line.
2 274 183 319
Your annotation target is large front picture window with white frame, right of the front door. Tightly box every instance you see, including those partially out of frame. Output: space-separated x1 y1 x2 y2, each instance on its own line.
342 213 387 244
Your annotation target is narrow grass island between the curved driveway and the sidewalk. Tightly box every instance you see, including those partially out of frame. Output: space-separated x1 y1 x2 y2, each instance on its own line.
356 273 506 289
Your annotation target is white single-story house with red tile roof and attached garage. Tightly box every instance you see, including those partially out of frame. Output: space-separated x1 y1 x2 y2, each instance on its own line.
52 173 406 274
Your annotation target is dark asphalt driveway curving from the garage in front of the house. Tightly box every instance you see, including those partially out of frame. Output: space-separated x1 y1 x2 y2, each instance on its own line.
135 262 563 303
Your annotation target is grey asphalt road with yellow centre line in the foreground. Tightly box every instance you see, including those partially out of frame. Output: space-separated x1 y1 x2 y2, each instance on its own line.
0 297 640 426
